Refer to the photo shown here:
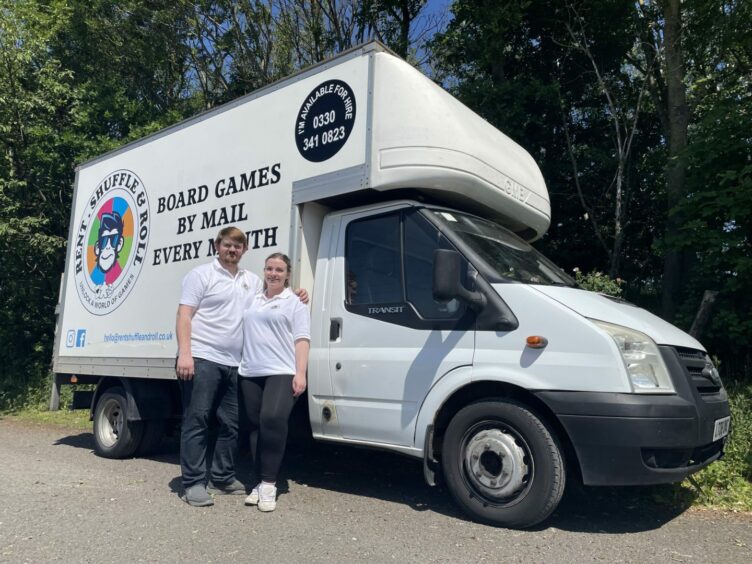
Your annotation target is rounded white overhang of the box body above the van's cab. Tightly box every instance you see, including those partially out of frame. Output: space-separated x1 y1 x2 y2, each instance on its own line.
370 53 551 239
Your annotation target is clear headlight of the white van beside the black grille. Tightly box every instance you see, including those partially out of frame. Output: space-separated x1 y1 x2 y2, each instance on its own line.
591 319 675 394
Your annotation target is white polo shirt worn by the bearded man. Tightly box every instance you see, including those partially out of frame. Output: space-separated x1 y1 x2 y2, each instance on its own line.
180 258 261 366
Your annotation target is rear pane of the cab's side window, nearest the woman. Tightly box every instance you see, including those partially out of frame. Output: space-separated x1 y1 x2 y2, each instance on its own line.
345 213 404 305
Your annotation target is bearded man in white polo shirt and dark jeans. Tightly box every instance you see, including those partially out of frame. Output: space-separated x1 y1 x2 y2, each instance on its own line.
175 227 308 507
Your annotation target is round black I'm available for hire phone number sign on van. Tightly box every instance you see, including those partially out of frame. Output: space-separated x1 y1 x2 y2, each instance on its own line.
295 80 355 163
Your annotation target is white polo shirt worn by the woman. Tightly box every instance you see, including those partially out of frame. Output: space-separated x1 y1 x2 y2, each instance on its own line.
238 288 311 376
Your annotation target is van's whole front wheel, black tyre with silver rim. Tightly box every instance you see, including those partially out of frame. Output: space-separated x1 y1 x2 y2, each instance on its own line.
442 399 565 528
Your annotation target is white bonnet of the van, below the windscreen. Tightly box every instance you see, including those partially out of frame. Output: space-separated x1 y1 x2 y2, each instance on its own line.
534 286 705 351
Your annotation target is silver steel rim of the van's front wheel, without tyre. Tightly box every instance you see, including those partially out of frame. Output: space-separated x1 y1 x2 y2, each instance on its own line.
463 427 532 503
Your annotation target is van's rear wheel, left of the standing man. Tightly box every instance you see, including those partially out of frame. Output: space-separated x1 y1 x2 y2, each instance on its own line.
94 387 144 458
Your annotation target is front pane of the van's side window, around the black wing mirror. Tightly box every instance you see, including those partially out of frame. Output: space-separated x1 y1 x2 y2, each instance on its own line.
404 212 467 319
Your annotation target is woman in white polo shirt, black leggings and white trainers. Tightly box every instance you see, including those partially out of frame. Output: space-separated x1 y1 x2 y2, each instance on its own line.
238 253 311 511
